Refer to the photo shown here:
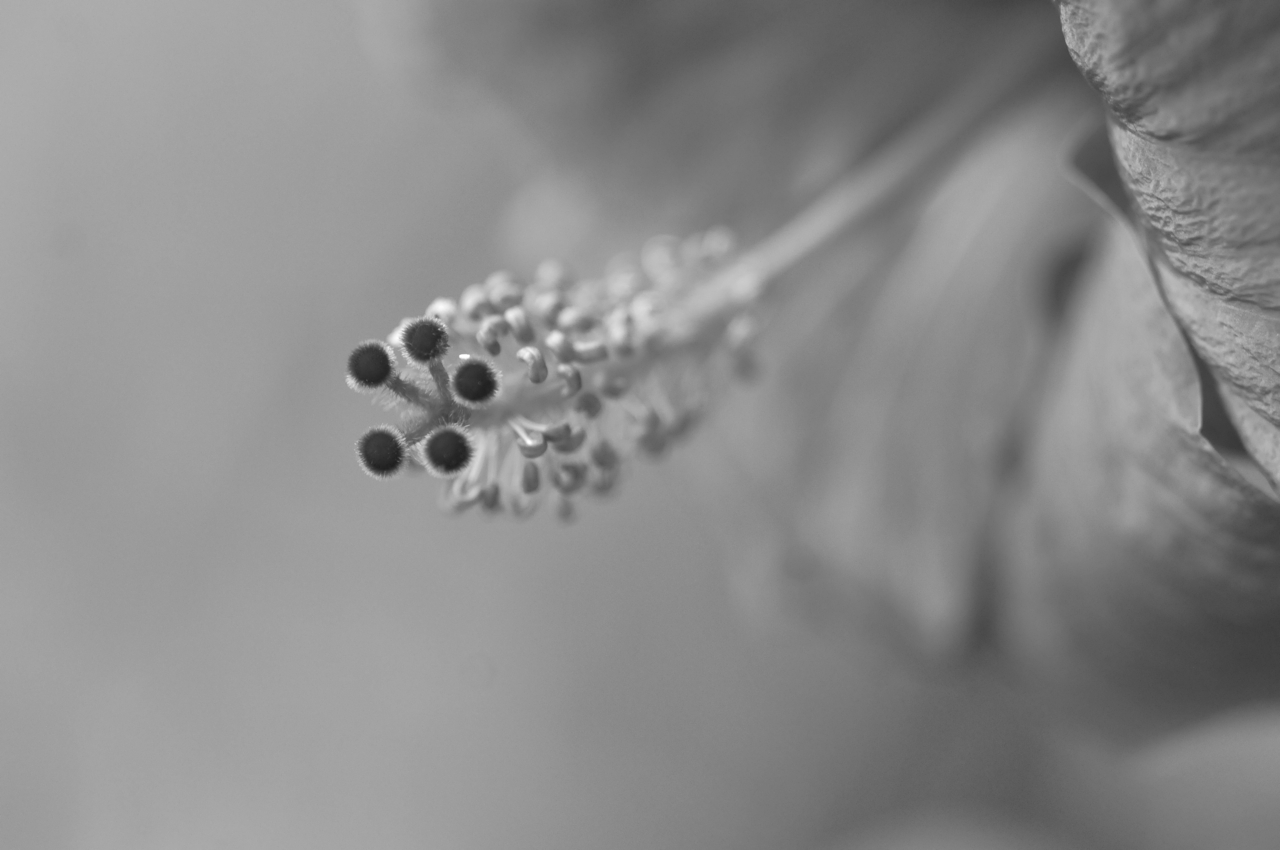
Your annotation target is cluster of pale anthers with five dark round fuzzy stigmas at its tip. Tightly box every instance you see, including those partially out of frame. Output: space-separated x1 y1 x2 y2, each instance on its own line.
347 230 751 517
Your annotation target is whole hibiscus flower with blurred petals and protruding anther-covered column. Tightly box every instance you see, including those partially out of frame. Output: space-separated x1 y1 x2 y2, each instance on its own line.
353 0 1280 752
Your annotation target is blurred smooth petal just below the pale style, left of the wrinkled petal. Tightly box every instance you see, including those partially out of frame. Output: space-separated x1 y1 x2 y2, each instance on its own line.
708 86 1098 661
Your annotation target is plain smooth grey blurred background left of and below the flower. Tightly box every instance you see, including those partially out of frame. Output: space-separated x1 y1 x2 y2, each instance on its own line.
0 0 1280 850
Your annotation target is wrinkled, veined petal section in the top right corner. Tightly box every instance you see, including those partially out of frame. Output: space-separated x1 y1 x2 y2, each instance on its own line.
1061 0 1280 481
